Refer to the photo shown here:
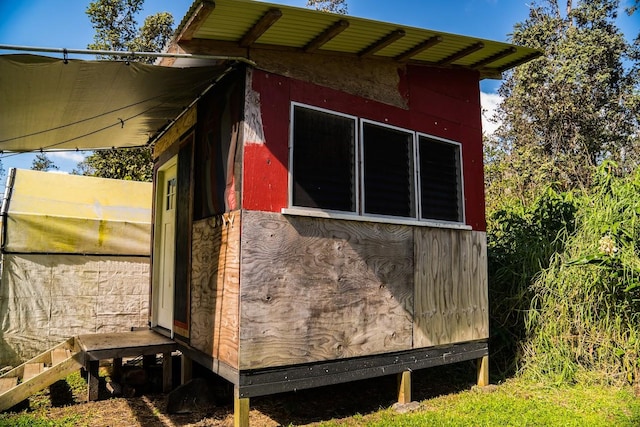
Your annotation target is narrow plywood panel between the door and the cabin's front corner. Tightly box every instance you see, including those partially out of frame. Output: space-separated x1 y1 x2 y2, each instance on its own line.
191 211 240 368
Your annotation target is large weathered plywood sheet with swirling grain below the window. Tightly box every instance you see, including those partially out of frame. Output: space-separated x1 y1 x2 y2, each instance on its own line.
240 211 414 369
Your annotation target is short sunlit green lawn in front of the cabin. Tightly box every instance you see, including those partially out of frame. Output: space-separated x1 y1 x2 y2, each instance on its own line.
322 380 640 427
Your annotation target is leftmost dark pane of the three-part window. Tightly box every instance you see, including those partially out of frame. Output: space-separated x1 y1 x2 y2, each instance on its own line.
292 105 356 212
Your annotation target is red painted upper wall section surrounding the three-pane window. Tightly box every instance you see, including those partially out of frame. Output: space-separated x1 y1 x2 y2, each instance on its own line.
242 66 486 231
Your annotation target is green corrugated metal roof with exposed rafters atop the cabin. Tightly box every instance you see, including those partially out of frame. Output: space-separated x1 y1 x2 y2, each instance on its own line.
176 0 541 77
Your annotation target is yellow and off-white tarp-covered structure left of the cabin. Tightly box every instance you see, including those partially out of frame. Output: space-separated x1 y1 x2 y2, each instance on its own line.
0 169 152 366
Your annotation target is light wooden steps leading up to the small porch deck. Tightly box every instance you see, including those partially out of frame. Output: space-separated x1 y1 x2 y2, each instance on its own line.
0 338 83 411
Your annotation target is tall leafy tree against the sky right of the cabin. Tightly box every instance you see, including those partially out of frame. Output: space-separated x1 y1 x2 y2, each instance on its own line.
488 0 640 200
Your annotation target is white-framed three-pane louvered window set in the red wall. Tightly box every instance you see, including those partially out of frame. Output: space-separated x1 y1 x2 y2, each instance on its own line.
290 103 464 223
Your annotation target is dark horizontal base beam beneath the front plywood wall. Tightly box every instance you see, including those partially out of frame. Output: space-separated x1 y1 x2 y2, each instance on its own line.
237 341 489 398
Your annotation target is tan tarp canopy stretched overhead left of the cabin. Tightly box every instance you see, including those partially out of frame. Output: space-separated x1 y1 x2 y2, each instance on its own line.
0 55 227 152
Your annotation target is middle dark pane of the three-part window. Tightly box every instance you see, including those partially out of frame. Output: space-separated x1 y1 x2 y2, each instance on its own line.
362 123 416 218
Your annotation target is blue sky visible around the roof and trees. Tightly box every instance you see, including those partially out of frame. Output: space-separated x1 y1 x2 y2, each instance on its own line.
0 0 640 177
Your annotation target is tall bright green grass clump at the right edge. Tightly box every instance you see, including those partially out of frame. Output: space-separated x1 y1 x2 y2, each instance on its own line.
522 163 640 384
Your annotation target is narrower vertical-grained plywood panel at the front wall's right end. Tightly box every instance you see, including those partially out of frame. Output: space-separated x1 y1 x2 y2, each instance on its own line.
413 228 489 348
